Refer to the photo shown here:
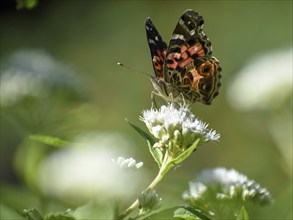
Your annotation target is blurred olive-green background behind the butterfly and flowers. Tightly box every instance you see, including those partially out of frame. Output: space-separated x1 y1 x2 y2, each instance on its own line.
1 0 292 219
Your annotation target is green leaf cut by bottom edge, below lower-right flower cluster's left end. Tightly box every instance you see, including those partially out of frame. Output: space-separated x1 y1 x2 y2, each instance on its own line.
174 207 210 220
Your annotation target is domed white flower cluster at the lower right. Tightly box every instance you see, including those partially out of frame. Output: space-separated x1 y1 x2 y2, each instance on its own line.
183 168 273 205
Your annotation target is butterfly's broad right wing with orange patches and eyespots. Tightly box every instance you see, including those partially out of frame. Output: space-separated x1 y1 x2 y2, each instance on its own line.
163 9 221 104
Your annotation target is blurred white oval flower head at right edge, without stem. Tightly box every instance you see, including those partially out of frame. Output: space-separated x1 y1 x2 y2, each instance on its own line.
227 48 293 110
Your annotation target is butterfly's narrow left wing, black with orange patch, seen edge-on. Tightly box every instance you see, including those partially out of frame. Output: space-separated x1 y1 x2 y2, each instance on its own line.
145 18 167 79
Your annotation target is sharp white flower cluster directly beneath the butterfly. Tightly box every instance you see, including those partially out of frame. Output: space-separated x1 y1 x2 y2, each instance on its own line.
140 103 220 149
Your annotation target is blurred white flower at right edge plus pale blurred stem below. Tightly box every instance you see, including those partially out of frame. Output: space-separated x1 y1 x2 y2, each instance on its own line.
227 47 293 176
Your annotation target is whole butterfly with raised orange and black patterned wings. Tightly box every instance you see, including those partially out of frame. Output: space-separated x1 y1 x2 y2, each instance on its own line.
145 9 222 104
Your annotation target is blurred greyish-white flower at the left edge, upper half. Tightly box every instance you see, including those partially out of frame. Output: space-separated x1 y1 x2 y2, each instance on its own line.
0 49 81 106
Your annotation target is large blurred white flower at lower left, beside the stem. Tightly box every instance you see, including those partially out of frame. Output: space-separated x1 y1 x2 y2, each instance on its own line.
39 132 146 202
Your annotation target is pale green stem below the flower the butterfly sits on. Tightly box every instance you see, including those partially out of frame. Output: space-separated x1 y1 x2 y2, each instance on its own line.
118 152 174 219
